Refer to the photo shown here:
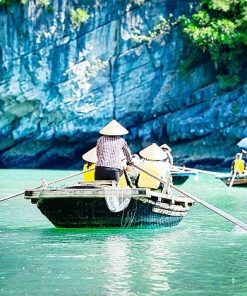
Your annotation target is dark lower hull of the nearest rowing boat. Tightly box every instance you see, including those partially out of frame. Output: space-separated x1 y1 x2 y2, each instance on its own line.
37 198 183 228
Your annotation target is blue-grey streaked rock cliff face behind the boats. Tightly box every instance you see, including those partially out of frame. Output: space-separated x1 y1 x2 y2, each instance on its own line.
0 0 247 168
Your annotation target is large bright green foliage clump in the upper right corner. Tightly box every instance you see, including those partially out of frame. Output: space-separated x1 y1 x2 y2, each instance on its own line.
180 0 247 89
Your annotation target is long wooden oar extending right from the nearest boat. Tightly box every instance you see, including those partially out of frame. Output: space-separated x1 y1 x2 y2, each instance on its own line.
131 163 247 231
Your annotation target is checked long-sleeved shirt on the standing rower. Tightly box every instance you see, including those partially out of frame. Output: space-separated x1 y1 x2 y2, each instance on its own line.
96 136 131 170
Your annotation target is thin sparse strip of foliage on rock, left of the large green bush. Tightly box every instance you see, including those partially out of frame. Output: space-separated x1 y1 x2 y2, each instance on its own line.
131 17 171 43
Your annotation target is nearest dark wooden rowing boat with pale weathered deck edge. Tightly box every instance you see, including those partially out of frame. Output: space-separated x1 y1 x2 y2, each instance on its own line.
25 181 194 228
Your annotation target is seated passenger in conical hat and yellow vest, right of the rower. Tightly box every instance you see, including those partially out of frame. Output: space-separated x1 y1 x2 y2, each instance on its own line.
138 143 170 191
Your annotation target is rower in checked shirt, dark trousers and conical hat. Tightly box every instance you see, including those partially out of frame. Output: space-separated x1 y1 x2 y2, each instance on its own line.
95 120 132 182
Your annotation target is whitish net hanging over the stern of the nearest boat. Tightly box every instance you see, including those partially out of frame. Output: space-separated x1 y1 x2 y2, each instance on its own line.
105 188 131 213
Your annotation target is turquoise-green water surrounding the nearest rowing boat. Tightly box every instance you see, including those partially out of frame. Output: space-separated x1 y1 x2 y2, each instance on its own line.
0 170 247 296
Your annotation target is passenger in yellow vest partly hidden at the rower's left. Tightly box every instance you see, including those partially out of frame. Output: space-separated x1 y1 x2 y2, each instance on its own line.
82 147 97 182
